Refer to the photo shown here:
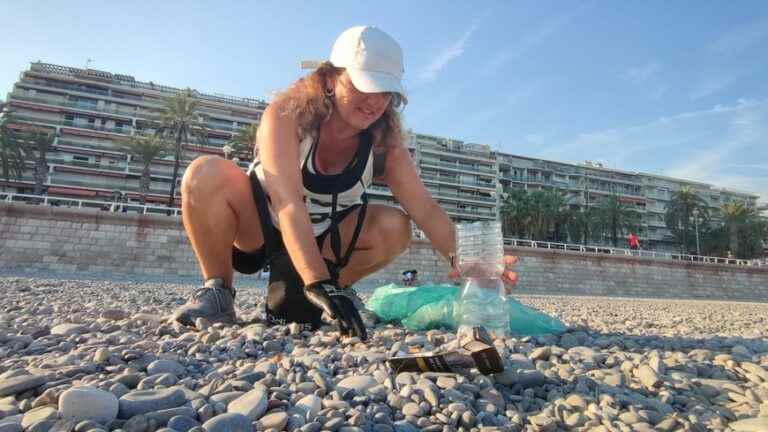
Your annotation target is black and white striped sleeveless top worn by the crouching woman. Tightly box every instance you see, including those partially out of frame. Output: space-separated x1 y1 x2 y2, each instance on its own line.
251 130 373 236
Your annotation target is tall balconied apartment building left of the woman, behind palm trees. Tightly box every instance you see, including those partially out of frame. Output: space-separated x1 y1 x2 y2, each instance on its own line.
0 62 267 208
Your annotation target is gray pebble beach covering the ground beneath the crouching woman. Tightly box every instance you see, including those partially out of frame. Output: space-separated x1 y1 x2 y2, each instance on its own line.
0 276 768 432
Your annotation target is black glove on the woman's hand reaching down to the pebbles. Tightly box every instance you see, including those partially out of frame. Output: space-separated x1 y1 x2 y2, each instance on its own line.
304 279 368 340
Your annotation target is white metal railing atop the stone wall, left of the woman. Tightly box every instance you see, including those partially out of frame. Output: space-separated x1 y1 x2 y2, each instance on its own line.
0 192 181 216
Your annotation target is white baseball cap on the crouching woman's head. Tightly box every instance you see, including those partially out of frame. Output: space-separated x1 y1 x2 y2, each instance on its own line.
301 26 408 103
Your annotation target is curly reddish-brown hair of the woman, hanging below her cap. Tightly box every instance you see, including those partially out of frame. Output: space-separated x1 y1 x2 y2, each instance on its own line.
273 61 405 175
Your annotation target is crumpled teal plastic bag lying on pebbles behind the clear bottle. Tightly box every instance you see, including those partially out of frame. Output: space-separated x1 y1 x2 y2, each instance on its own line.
367 284 567 336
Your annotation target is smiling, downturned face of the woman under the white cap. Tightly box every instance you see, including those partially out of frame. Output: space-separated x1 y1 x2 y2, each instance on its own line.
333 72 392 130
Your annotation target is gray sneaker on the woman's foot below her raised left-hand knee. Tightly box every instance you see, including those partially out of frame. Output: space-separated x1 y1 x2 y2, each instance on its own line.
173 278 236 326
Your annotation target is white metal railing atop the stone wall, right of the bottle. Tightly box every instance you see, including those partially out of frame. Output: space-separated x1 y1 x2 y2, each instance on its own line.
504 238 768 267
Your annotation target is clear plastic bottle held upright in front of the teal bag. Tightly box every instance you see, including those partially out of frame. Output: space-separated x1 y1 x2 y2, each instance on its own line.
456 221 509 337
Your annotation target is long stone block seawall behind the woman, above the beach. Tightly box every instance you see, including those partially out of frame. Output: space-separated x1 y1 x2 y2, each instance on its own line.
0 203 768 301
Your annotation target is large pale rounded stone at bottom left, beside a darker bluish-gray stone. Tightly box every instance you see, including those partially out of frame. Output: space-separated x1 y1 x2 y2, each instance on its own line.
59 386 119 425
